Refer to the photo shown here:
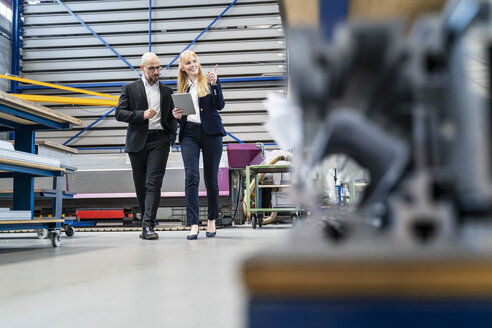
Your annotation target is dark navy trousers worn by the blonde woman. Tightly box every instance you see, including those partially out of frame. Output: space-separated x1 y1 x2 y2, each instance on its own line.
180 122 222 225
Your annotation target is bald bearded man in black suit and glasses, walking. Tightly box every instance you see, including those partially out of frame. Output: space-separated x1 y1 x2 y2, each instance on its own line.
116 52 177 240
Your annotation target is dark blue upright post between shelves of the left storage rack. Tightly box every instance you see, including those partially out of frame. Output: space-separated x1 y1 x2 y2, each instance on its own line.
13 129 34 218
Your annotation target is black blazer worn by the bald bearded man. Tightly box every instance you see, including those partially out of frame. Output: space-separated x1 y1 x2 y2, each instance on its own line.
115 79 177 152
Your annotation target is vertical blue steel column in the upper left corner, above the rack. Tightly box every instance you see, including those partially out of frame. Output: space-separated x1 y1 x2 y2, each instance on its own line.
10 0 22 93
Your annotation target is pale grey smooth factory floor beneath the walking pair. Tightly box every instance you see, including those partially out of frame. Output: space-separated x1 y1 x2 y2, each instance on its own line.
0 225 290 328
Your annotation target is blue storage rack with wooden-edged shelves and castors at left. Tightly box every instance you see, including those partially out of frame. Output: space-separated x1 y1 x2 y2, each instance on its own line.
0 92 81 247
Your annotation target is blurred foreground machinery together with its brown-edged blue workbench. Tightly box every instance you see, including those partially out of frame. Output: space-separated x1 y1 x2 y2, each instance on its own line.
242 0 492 328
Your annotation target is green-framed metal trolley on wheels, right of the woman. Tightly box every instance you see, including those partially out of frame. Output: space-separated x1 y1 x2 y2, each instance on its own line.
246 164 301 229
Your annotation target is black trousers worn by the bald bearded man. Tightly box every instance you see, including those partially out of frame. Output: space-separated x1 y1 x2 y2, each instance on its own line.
128 131 170 228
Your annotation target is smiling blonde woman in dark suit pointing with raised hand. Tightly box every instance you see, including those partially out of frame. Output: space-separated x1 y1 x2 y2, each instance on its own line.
173 50 226 240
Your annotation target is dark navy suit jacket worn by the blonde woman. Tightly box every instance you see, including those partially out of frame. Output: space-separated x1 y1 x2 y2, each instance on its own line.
179 80 226 140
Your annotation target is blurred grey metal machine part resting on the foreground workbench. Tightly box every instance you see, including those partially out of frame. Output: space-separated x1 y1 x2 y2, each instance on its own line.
287 0 492 242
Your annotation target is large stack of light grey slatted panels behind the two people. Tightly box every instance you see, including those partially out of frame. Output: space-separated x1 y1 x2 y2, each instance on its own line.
22 0 287 147
